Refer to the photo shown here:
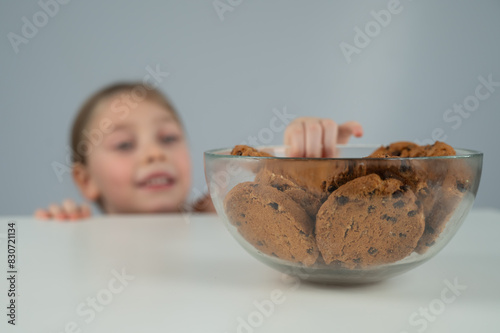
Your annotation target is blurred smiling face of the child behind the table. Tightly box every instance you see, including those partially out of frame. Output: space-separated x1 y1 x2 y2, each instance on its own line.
80 98 191 214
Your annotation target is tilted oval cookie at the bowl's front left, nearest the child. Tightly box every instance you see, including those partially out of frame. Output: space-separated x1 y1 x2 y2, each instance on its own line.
224 182 319 266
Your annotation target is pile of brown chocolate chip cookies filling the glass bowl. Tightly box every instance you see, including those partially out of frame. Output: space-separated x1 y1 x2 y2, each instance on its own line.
224 142 471 269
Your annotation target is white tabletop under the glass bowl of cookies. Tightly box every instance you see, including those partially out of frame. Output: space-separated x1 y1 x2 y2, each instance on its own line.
0 210 500 333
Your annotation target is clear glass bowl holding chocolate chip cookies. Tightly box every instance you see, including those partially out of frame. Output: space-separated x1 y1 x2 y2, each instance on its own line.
204 145 483 284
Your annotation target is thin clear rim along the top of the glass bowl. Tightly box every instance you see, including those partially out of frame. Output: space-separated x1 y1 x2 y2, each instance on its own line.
204 144 483 161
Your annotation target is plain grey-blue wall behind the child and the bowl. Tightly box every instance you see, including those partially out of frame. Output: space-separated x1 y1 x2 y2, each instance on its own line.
0 0 500 215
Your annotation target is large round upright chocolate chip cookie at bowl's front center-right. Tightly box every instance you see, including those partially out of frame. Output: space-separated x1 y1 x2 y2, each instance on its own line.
315 174 425 268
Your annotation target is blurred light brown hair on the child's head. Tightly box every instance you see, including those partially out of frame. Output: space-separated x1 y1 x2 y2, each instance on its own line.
70 82 183 165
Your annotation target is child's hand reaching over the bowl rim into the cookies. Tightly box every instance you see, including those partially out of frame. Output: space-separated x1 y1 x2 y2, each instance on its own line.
284 117 363 158
